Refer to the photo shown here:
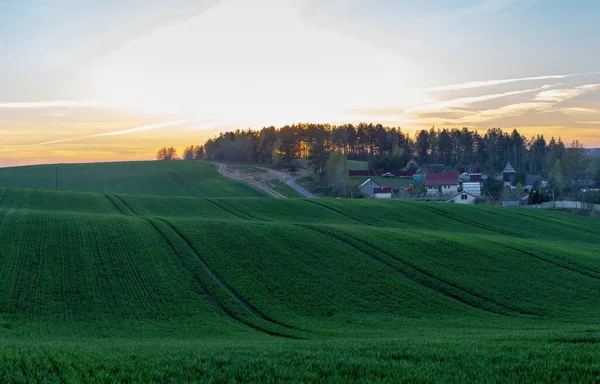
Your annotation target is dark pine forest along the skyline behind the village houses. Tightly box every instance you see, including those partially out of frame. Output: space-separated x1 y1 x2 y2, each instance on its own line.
188 123 600 180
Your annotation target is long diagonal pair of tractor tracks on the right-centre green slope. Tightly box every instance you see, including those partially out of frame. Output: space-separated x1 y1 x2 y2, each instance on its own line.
301 225 540 317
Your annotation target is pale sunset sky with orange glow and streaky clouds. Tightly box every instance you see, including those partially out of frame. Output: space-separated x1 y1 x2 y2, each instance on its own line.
0 0 600 166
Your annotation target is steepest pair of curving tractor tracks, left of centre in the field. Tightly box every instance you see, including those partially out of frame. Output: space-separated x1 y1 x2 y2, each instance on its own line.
105 195 302 339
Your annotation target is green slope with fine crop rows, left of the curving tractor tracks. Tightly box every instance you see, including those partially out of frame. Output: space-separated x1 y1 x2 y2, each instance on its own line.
0 211 236 330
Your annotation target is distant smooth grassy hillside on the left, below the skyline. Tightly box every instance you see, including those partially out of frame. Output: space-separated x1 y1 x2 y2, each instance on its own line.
0 161 264 197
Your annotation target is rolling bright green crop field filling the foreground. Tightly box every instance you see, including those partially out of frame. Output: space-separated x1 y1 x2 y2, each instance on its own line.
0 163 600 383
